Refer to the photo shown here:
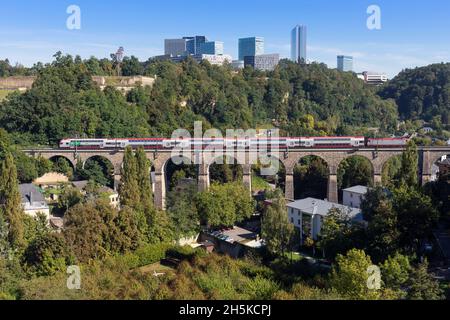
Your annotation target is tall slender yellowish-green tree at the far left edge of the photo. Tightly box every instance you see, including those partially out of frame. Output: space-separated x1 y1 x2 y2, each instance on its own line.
0 150 25 249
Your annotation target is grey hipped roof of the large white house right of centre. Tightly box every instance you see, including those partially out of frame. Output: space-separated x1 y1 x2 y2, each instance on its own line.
287 198 363 221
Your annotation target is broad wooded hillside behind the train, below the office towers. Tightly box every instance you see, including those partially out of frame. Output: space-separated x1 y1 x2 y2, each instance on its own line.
0 54 397 144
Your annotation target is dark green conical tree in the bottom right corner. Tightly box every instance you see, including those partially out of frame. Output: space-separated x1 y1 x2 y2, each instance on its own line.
407 260 443 300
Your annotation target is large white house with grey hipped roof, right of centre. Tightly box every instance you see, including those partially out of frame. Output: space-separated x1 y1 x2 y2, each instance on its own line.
287 198 363 243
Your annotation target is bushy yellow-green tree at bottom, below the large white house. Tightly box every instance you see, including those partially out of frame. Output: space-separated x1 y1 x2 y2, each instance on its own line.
330 249 380 300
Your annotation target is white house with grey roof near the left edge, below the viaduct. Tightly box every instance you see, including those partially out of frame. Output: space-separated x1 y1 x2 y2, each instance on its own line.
19 183 50 220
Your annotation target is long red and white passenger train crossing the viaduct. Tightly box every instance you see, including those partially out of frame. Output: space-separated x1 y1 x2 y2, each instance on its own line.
59 137 409 150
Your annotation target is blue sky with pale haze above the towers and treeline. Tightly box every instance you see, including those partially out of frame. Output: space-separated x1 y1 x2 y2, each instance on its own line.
0 0 450 77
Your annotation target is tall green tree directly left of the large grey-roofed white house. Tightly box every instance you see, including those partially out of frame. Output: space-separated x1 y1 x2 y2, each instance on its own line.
261 197 294 256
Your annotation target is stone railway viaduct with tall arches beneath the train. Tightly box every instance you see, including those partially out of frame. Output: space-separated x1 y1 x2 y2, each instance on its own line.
25 146 450 209
